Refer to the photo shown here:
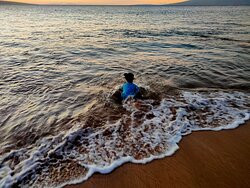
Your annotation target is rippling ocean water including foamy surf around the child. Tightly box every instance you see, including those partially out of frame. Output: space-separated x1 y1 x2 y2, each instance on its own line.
0 5 250 187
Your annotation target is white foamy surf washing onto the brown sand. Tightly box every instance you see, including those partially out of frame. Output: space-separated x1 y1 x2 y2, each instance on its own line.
0 91 250 187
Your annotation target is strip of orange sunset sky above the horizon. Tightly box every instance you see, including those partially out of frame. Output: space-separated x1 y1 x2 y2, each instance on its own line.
3 0 188 5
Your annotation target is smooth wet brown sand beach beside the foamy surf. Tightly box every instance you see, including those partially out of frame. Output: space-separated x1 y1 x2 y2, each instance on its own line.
65 121 250 188
